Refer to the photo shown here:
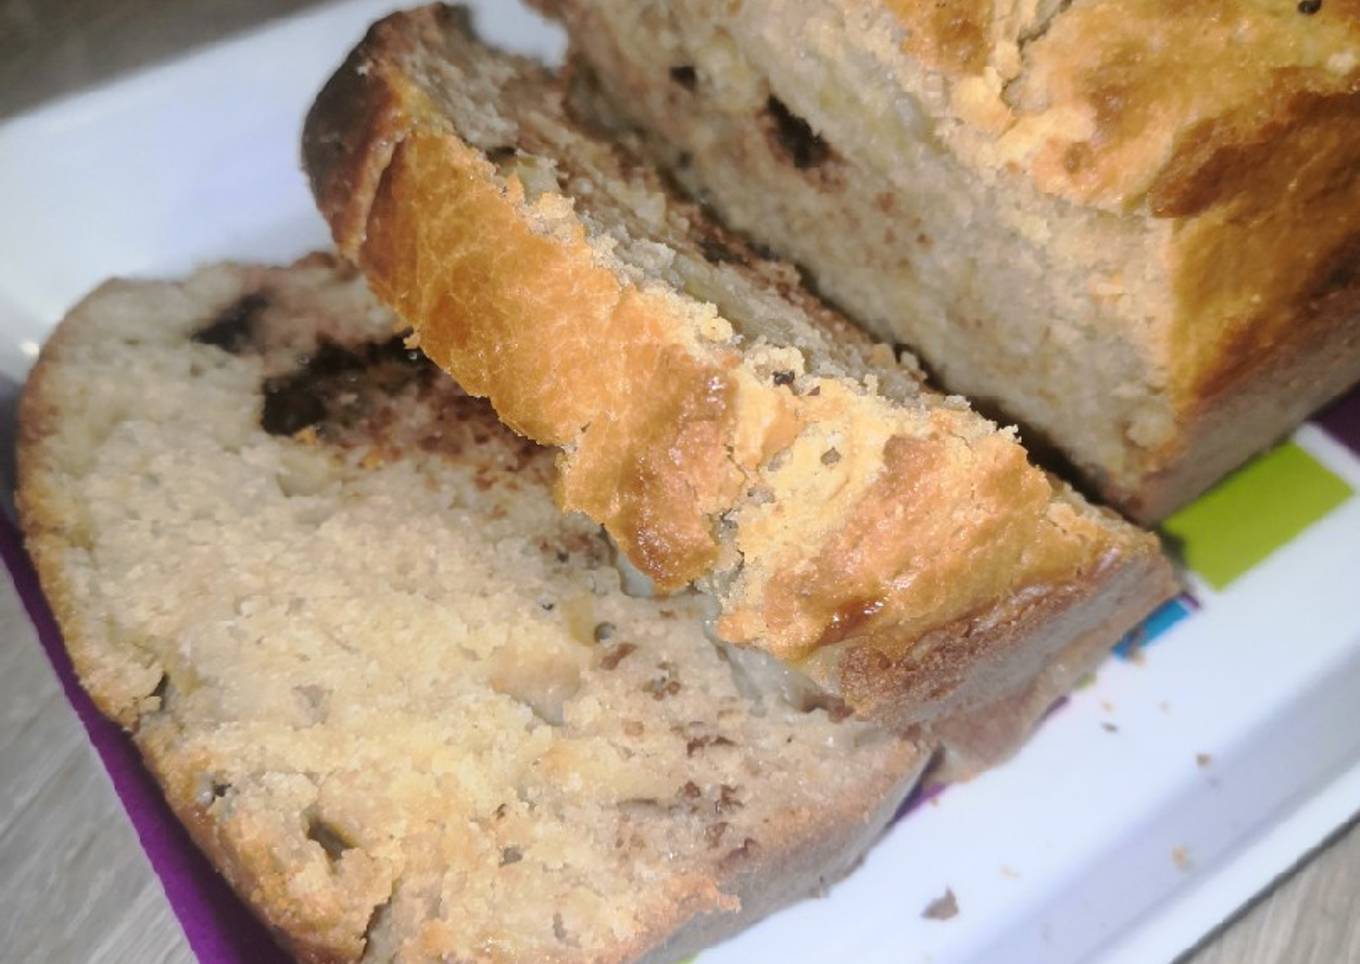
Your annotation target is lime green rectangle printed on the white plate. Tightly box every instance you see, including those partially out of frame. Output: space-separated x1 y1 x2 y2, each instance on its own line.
1161 442 1350 589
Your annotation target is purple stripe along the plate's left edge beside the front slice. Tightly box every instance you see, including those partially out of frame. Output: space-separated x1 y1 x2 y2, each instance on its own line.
0 513 288 964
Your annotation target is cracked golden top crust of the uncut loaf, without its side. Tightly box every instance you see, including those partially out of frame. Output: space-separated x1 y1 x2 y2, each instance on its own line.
881 0 1360 210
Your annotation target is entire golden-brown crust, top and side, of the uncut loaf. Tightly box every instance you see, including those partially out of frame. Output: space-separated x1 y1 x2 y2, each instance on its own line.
881 0 1360 511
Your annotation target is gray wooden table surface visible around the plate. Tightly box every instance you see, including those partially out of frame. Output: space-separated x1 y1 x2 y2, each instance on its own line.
0 0 1360 964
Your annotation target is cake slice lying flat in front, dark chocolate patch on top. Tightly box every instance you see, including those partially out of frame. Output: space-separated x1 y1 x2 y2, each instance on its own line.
18 256 928 963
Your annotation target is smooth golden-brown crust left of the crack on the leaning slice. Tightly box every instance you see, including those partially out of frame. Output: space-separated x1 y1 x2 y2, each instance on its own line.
303 24 733 589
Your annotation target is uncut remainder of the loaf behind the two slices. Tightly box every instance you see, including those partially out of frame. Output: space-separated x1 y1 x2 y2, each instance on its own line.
536 0 1360 521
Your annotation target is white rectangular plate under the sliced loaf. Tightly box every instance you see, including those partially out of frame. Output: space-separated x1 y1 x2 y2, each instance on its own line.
0 0 1360 964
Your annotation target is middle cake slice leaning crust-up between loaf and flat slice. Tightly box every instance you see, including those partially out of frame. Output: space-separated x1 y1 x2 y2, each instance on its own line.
303 7 1172 763
